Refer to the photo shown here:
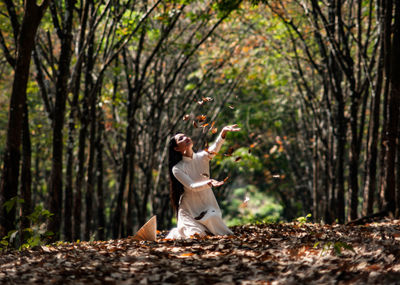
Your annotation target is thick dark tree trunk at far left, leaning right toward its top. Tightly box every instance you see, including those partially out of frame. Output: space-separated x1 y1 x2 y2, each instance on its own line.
0 0 49 236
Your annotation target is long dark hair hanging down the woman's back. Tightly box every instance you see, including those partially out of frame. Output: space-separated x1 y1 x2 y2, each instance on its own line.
168 133 184 217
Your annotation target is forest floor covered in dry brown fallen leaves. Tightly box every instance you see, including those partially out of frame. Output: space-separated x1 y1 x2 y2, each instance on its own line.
0 217 400 284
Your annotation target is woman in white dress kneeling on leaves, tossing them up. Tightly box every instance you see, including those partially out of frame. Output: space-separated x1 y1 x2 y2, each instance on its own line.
166 125 240 239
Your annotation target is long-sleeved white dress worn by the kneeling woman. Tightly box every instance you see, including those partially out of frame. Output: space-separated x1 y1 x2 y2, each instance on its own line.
166 135 233 239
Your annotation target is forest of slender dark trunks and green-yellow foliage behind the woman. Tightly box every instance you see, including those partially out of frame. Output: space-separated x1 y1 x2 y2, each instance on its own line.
0 0 400 240
